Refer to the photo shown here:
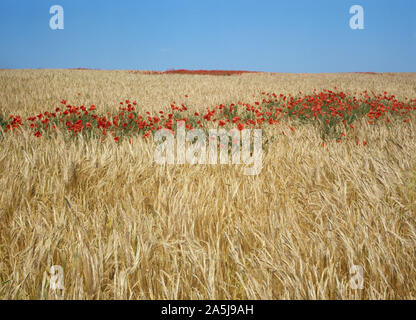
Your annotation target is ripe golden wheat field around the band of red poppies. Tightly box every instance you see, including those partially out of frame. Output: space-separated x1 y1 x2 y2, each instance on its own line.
0 70 416 299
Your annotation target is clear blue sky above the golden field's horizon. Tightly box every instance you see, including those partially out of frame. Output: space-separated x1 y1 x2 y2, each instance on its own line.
0 0 416 73
